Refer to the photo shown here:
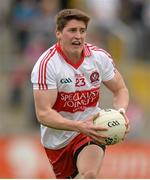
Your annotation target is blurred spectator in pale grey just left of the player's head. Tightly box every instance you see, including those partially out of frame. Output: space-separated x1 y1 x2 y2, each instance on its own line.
30 0 59 47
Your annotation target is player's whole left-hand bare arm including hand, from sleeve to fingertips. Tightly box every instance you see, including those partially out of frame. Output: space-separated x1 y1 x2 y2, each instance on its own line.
34 90 107 143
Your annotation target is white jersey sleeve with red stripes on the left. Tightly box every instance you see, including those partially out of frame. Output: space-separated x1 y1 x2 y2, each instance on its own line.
31 53 57 90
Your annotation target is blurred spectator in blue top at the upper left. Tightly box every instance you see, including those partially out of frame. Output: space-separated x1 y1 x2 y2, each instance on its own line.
12 0 38 52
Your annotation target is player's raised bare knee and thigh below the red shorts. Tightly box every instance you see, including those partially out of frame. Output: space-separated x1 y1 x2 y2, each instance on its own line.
76 144 104 173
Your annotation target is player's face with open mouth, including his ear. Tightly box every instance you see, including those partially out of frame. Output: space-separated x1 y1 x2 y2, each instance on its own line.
56 20 86 56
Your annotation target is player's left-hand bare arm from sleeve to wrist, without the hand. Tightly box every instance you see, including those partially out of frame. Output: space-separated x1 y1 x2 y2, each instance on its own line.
34 90 78 131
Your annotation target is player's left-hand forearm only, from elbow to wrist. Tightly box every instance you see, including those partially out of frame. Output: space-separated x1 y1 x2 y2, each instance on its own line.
37 109 79 132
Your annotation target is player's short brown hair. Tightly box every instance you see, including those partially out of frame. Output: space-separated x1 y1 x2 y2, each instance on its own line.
56 9 90 31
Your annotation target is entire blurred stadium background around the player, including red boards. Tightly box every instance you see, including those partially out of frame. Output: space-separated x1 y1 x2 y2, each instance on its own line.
0 0 150 179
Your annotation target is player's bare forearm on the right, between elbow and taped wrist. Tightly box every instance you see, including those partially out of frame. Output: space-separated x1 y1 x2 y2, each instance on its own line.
113 88 129 110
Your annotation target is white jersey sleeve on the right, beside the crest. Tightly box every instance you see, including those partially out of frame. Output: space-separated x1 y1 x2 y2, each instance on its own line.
101 53 115 81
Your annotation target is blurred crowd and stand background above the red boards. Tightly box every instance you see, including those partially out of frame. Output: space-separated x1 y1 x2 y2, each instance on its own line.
0 0 150 179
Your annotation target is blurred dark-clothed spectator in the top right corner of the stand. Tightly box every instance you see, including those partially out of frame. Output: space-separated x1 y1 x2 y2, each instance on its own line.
120 0 150 60
